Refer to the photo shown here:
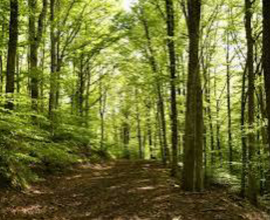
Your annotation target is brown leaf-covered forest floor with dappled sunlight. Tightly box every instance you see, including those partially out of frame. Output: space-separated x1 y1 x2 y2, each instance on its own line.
0 161 270 220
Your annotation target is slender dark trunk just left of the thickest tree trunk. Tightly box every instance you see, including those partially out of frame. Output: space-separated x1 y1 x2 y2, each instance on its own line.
166 0 178 176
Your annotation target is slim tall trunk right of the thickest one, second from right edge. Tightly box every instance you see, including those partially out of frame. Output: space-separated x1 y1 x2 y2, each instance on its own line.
245 0 257 204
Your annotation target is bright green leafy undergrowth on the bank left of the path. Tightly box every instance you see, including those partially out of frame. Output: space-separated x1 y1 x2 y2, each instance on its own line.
0 106 110 189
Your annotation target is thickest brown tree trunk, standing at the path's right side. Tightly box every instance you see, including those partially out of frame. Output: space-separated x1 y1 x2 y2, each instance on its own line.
183 0 203 191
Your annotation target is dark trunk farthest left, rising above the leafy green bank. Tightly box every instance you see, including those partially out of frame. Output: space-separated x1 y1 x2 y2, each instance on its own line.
6 0 19 110
